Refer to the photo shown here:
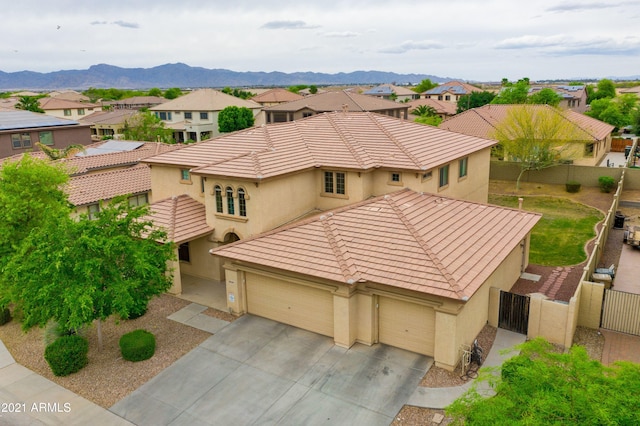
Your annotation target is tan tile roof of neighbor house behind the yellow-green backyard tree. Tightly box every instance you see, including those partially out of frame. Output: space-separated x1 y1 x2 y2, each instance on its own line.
438 104 614 142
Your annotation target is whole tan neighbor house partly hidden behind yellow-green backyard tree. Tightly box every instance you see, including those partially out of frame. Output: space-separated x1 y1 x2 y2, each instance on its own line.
438 104 614 166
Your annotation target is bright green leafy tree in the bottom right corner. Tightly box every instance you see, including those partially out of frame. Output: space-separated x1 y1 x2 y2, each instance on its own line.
446 338 640 425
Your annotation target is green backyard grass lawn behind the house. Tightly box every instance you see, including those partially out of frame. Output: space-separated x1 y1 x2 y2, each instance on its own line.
489 194 603 266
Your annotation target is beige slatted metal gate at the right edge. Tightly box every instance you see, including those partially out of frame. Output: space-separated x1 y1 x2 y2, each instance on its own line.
600 290 640 336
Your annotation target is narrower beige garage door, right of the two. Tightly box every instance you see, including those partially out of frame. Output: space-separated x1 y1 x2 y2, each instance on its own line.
378 296 436 356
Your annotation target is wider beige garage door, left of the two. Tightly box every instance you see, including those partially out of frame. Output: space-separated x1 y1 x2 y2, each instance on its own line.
246 273 333 337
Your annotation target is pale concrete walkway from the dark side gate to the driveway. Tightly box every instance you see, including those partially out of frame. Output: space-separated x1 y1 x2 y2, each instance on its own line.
407 328 527 409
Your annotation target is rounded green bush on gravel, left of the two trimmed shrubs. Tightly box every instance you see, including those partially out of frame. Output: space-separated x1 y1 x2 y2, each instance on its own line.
44 334 89 376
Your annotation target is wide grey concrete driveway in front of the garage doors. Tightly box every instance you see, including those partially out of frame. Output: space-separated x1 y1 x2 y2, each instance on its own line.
110 315 432 426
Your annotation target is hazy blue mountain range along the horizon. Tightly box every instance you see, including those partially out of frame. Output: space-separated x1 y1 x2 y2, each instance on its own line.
0 63 452 91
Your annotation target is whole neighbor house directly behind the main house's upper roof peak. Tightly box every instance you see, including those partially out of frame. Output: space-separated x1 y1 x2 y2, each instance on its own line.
264 90 409 123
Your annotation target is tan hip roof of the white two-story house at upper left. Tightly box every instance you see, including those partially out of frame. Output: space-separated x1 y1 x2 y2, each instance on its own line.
149 89 262 111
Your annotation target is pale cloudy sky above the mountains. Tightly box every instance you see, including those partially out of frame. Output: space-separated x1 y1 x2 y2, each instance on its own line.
0 0 640 81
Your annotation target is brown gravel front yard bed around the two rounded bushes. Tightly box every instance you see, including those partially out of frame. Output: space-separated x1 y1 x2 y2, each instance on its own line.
0 294 226 408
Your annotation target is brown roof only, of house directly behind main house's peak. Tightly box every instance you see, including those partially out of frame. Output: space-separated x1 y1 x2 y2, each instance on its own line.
264 90 407 113
